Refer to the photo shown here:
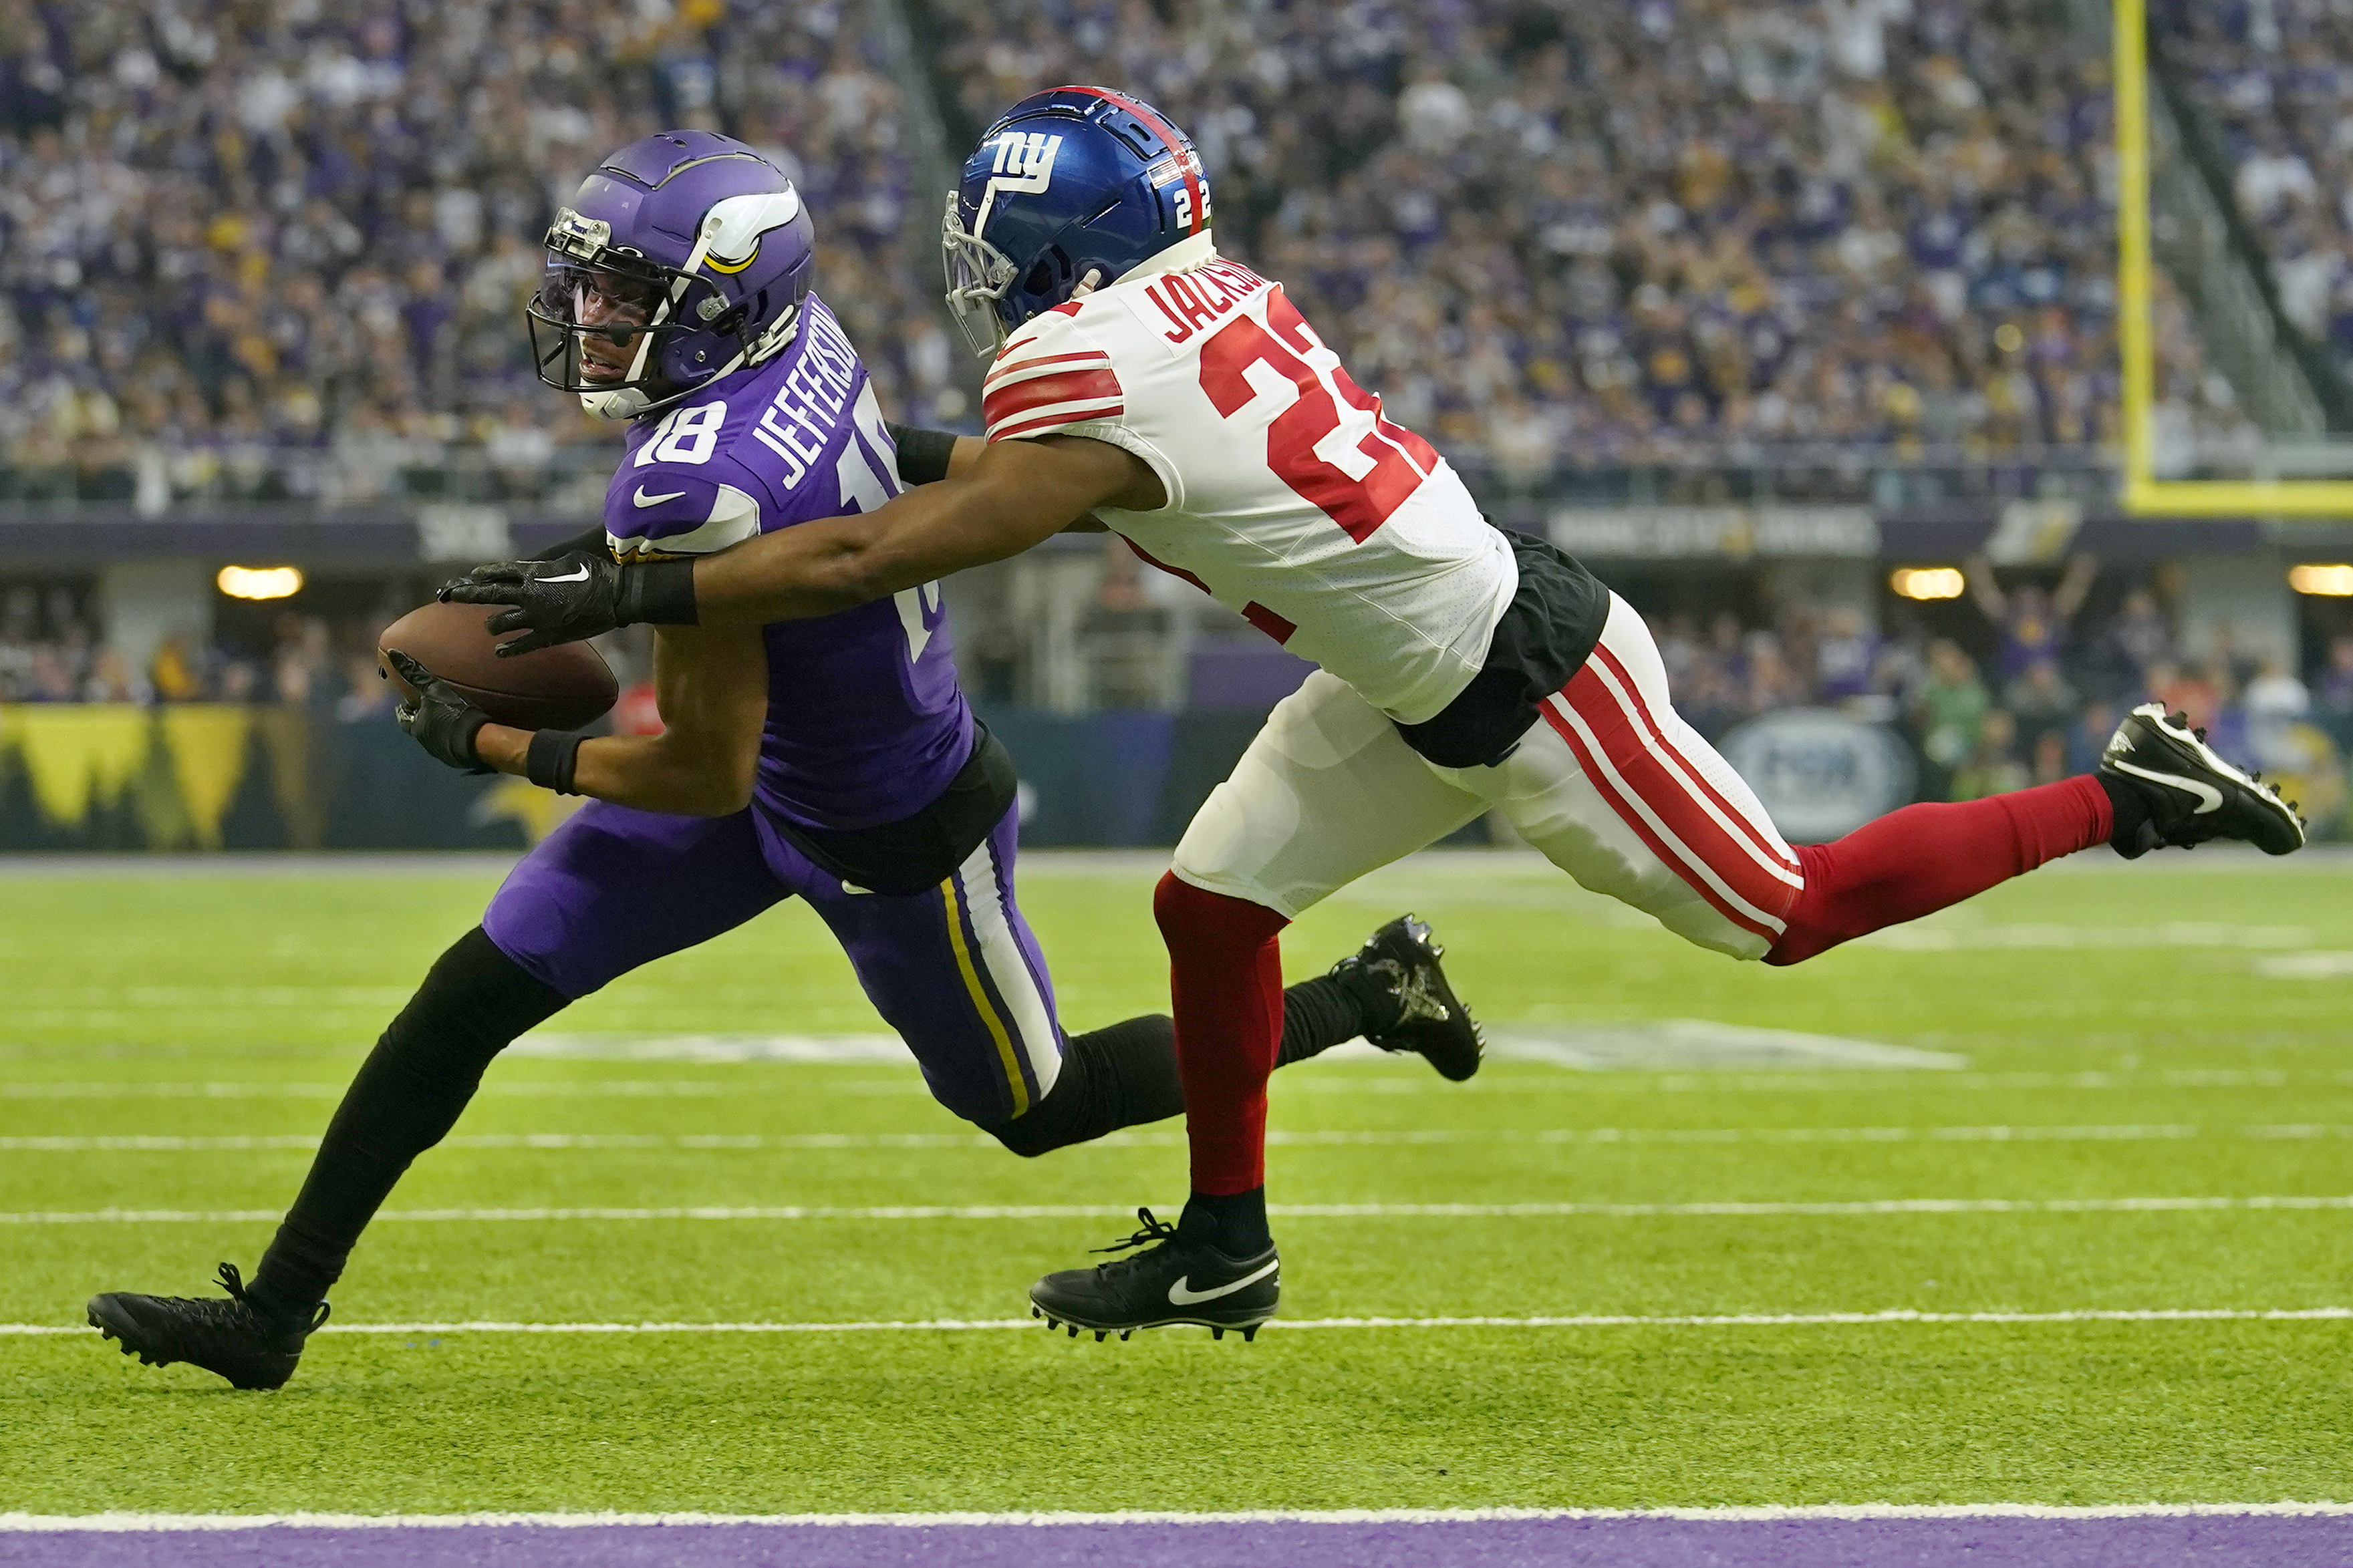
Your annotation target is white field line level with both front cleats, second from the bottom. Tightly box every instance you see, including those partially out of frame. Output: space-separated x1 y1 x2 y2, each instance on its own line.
0 1307 2353 1338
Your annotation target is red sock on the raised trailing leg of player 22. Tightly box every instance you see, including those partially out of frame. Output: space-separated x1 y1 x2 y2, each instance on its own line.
1765 774 2115 964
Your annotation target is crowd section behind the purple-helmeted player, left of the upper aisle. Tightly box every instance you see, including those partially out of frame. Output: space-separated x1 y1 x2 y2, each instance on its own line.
0 0 962 503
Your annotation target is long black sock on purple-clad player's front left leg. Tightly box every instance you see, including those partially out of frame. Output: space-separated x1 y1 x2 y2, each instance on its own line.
252 926 569 1316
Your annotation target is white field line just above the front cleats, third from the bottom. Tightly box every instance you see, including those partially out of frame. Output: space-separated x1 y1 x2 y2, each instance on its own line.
0 1195 2353 1225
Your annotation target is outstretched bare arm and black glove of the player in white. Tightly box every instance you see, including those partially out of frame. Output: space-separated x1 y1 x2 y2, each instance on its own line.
440 435 1167 656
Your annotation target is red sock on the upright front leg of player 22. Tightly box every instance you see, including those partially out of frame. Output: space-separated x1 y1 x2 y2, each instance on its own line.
1153 872 1292 1195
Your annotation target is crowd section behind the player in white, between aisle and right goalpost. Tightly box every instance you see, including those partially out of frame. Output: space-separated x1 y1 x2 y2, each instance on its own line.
930 0 2245 484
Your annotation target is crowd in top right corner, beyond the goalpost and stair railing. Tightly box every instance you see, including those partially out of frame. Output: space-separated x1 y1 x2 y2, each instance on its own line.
2155 0 2353 390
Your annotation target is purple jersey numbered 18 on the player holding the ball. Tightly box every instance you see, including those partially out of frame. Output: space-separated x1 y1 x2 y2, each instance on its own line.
605 294 972 828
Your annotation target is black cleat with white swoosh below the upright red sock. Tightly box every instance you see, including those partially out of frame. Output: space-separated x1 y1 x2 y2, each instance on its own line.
1030 1209 1282 1340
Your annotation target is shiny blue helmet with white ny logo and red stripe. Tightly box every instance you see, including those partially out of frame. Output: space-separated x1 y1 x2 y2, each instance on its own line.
939 87 1210 357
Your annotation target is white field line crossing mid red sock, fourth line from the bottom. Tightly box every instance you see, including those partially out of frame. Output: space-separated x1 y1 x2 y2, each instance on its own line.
13 1121 2353 1154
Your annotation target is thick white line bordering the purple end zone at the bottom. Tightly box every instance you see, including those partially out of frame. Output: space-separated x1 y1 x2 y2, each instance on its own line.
0 1502 2353 1533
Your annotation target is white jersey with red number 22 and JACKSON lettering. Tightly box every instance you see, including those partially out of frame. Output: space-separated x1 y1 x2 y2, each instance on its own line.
981 235 1520 724
